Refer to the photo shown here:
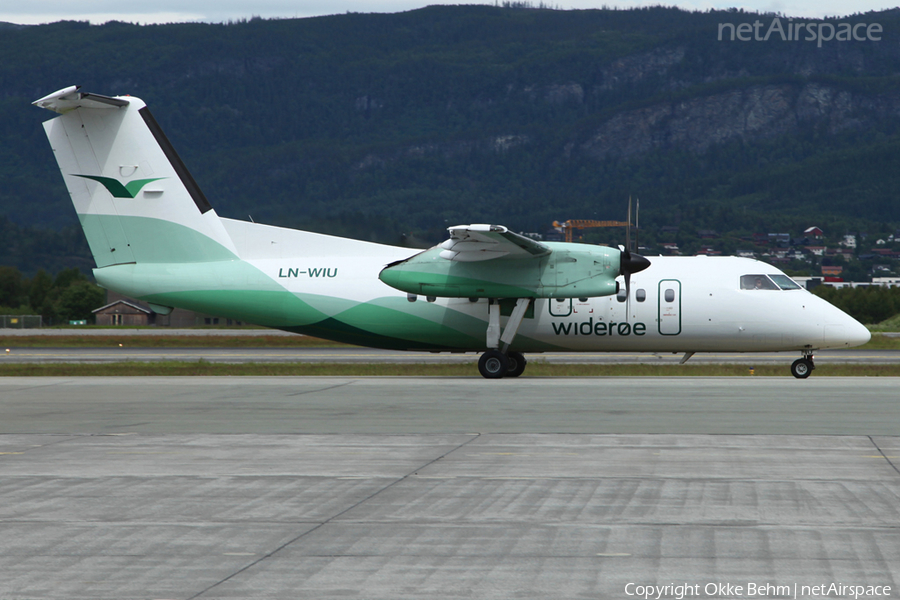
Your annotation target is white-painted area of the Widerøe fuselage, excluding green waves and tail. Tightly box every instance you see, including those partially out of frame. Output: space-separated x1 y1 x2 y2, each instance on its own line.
223 219 869 352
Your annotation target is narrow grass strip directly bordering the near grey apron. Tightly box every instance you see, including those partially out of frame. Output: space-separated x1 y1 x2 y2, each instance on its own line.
0 360 900 377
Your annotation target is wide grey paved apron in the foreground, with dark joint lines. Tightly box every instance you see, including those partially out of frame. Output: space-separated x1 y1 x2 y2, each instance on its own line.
0 377 900 599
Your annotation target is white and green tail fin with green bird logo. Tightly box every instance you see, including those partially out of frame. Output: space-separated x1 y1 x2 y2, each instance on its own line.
34 86 237 268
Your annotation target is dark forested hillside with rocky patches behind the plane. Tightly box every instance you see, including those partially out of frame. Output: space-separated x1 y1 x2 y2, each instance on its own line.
0 6 900 273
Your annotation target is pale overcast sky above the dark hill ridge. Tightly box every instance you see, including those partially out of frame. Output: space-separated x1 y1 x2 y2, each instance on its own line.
0 0 897 24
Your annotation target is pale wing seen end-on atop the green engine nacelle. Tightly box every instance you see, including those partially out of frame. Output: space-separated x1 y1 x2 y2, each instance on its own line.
440 225 550 262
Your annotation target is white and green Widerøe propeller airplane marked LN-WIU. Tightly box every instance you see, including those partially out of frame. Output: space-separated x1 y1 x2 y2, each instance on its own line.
33 86 870 379
